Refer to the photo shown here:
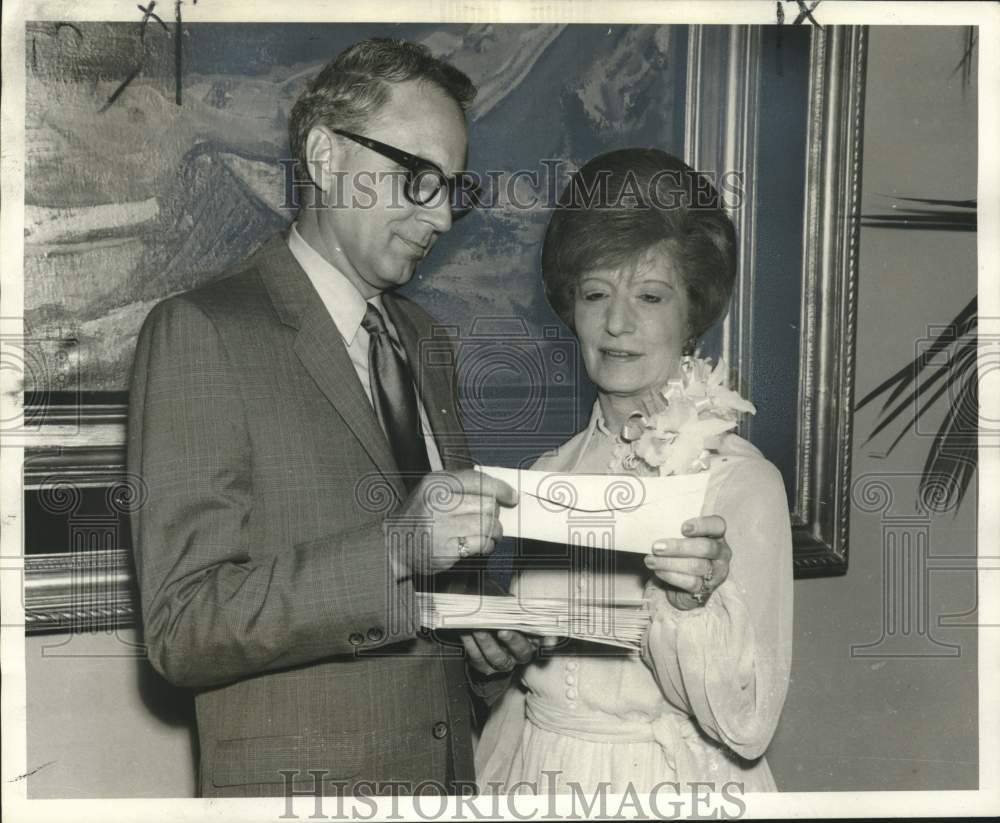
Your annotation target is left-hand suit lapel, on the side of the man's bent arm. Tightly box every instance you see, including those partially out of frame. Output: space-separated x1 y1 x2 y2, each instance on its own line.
259 237 406 499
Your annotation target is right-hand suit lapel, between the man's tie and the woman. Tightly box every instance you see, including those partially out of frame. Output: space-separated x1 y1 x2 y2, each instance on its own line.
382 293 472 471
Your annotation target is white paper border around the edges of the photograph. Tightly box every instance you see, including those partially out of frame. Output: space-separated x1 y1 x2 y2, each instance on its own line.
0 0 1000 823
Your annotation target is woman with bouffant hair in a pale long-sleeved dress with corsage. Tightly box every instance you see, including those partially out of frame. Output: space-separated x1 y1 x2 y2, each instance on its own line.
476 149 792 793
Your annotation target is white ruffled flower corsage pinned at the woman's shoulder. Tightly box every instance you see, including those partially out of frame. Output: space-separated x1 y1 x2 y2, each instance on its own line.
609 357 757 477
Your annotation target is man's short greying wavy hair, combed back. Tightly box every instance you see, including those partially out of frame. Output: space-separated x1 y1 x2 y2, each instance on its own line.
288 37 476 180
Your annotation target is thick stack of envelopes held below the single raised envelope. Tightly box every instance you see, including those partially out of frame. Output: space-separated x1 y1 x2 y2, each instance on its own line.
417 592 649 651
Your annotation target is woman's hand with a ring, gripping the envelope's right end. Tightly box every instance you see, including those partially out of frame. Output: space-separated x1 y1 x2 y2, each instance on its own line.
644 514 733 610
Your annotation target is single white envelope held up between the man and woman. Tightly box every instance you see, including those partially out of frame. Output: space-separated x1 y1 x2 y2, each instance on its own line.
476 466 709 554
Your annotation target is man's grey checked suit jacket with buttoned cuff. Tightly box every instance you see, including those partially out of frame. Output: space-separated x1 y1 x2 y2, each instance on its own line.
128 236 473 796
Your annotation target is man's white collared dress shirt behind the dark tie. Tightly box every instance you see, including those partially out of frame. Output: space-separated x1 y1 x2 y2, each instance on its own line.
288 223 444 471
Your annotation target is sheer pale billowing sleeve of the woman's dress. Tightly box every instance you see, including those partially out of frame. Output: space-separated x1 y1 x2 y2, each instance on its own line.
643 459 792 759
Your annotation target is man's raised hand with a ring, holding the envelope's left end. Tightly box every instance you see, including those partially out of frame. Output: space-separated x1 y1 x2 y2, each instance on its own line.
387 469 517 579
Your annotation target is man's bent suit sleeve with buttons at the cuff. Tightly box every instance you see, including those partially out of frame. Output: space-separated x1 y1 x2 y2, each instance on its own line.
128 298 419 687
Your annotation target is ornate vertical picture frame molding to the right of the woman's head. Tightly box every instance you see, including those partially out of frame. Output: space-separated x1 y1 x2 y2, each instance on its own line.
685 26 867 577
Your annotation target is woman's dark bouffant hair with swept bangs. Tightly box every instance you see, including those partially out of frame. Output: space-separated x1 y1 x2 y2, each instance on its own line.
542 148 736 338
